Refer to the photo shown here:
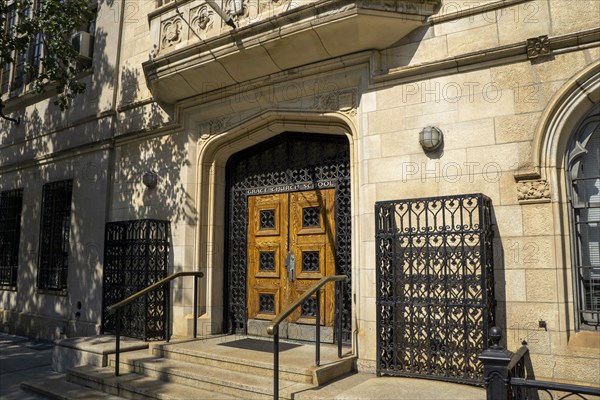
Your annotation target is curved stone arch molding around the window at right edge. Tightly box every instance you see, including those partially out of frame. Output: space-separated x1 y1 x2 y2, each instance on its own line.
515 62 600 339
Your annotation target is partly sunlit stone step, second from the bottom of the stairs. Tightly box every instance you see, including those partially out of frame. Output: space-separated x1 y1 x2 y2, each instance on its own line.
68 366 238 400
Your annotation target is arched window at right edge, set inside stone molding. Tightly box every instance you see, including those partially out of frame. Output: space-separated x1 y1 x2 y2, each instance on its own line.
566 106 600 329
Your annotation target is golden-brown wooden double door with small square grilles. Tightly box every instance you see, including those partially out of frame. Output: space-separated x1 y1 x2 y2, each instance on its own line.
248 189 335 327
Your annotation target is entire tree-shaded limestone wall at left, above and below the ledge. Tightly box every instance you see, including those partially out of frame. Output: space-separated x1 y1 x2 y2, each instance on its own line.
0 2 120 339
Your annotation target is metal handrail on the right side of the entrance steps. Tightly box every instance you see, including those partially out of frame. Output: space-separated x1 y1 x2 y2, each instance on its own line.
267 275 348 400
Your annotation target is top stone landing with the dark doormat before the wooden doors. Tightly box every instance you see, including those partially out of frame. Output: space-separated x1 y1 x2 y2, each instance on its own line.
149 336 355 385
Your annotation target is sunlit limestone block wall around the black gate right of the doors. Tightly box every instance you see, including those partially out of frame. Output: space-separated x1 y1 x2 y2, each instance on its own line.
358 1 600 384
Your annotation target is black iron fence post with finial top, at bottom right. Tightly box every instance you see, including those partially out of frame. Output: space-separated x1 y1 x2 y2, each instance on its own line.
479 326 513 400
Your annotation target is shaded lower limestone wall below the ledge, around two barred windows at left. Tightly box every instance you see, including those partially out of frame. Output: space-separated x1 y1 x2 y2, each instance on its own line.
0 151 108 339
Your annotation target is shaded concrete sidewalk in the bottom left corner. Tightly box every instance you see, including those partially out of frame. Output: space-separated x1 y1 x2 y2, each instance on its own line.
0 333 56 400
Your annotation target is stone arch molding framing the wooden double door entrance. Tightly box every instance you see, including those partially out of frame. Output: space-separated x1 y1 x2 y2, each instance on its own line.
195 110 357 333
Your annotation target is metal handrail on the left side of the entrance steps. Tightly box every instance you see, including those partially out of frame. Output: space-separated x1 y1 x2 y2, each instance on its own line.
106 271 204 376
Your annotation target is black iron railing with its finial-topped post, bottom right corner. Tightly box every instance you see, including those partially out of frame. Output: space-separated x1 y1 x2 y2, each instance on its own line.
479 327 600 400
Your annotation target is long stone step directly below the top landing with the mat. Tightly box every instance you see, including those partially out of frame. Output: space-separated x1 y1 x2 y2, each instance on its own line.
96 350 314 399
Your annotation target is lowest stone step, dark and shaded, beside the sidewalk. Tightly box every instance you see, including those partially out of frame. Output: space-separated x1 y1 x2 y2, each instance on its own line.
21 374 123 400
